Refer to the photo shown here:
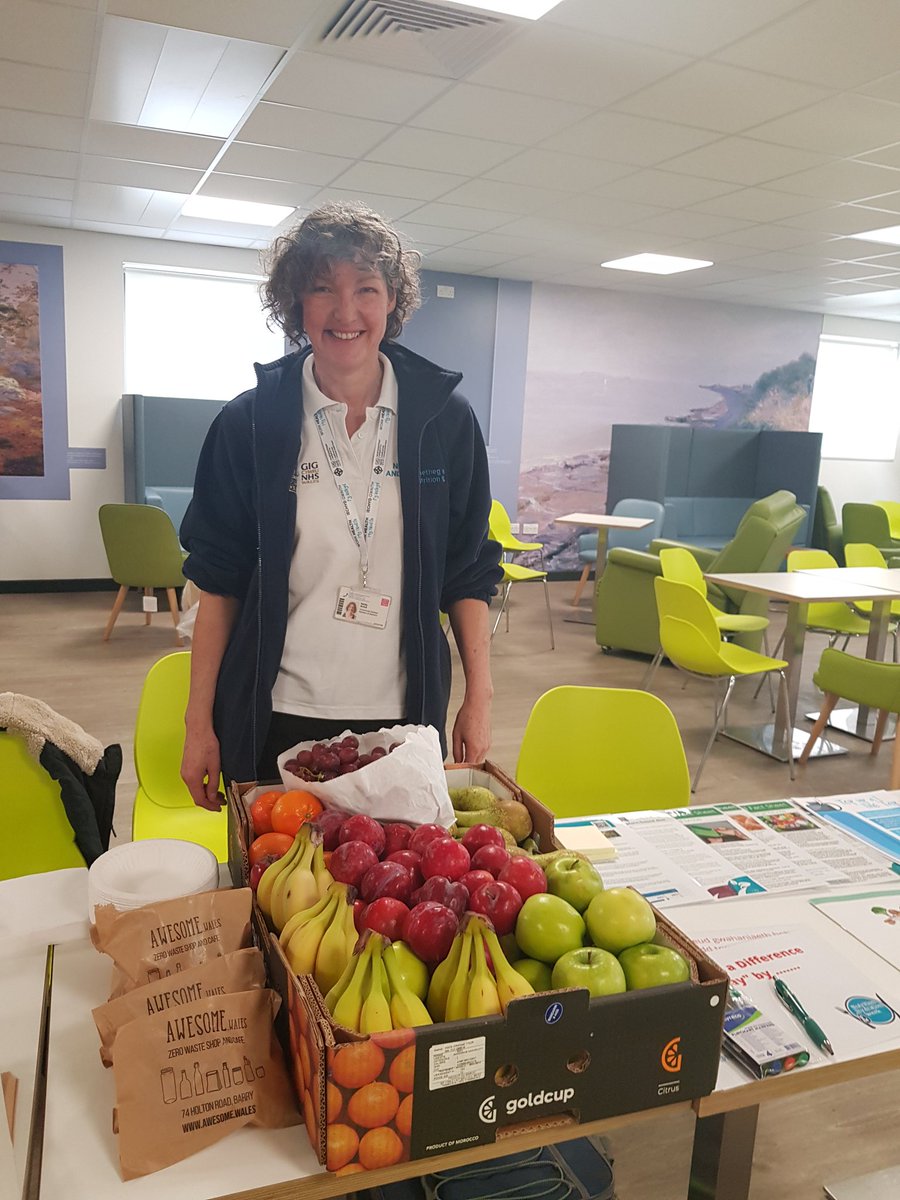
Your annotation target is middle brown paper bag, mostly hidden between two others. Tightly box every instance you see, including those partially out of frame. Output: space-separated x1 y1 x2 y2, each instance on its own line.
94 946 265 1067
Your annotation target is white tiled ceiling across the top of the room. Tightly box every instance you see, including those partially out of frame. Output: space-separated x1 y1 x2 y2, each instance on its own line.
8 0 900 319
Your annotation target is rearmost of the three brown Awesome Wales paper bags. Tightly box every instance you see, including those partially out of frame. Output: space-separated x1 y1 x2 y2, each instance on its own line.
91 888 252 1000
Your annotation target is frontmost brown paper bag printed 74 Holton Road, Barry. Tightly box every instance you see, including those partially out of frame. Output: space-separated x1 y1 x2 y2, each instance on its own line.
113 989 300 1180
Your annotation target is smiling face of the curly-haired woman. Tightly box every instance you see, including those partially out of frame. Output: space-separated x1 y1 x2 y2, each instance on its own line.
302 262 396 373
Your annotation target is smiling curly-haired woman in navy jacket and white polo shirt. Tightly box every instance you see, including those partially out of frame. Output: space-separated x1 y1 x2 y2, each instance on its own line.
181 205 502 808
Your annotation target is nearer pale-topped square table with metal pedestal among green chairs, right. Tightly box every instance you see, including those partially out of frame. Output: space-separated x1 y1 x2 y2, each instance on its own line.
706 566 900 762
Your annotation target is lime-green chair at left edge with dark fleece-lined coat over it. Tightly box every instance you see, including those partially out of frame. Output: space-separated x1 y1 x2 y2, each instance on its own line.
0 730 86 880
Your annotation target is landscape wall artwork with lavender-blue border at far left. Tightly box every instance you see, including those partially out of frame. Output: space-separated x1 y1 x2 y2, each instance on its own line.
0 241 70 500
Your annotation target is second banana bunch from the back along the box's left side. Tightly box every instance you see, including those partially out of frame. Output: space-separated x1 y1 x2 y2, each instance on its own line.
278 882 356 994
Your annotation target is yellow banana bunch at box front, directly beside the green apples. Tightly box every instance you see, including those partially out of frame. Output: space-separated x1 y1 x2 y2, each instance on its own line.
426 913 534 1021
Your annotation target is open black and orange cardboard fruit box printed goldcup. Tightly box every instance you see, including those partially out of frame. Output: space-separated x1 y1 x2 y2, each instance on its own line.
229 763 727 1175
